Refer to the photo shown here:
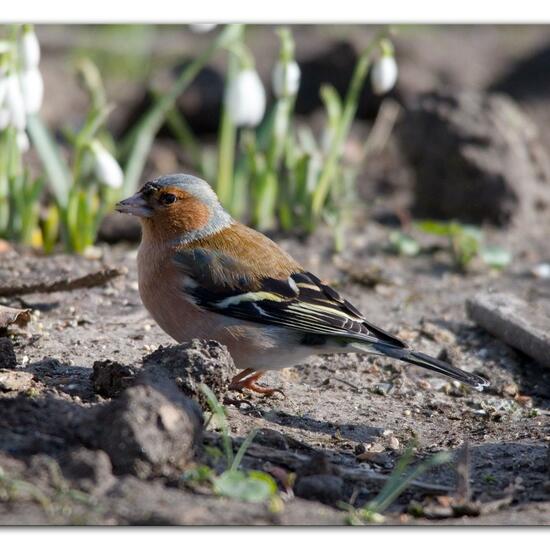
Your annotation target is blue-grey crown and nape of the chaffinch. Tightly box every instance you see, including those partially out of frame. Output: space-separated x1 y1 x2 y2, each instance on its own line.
150 174 234 244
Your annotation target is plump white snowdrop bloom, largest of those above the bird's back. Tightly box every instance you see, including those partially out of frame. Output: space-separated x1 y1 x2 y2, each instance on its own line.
227 69 265 127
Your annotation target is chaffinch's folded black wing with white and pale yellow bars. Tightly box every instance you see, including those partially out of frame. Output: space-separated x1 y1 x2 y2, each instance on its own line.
174 248 407 348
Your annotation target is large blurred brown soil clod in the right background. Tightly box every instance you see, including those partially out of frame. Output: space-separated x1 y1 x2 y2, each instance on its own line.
396 92 550 226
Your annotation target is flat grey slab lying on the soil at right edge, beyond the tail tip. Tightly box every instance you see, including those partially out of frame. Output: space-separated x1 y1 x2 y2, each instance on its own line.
466 292 550 367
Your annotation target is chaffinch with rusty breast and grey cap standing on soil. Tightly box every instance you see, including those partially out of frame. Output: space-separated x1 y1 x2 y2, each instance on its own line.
116 174 488 396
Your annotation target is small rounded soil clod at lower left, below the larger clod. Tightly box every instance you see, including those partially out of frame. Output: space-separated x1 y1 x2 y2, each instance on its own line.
60 447 115 496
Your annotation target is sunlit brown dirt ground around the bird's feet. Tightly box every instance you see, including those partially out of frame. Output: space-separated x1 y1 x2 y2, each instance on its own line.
0 211 550 524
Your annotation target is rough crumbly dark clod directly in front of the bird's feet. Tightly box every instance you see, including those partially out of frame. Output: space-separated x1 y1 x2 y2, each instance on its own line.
140 340 237 408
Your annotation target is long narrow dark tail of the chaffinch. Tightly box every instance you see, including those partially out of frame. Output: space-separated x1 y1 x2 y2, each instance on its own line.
352 342 489 391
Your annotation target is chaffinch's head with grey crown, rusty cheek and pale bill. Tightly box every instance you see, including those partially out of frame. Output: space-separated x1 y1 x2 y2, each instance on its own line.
116 174 233 242
